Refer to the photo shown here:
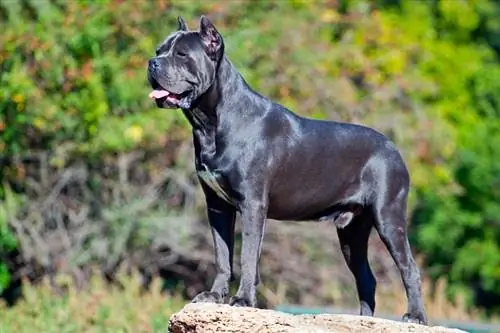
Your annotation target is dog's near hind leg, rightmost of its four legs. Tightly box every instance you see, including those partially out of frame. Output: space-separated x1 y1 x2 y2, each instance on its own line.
374 189 427 324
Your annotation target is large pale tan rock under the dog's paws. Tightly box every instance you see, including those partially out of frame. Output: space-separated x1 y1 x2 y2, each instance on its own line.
168 303 464 333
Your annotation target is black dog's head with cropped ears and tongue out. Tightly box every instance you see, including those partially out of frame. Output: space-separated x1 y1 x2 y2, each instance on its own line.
148 16 224 109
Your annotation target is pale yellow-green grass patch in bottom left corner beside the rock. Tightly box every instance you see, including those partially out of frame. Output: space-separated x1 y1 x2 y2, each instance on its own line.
0 270 185 333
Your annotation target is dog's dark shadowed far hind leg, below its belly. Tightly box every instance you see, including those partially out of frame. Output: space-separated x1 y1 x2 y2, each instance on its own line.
337 212 376 316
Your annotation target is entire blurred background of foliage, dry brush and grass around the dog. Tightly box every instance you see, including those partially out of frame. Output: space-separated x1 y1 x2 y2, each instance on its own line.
0 0 500 332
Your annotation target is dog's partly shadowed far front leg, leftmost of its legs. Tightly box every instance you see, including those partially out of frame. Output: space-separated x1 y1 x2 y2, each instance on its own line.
192 189 236 303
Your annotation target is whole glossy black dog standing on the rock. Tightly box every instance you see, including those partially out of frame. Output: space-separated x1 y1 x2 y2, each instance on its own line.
148 16 427 324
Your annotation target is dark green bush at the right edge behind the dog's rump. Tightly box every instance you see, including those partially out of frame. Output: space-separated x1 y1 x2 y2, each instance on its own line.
415 105 500 310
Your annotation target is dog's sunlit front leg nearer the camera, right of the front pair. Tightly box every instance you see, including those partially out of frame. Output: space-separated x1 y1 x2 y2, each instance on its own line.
229 200 267 307
